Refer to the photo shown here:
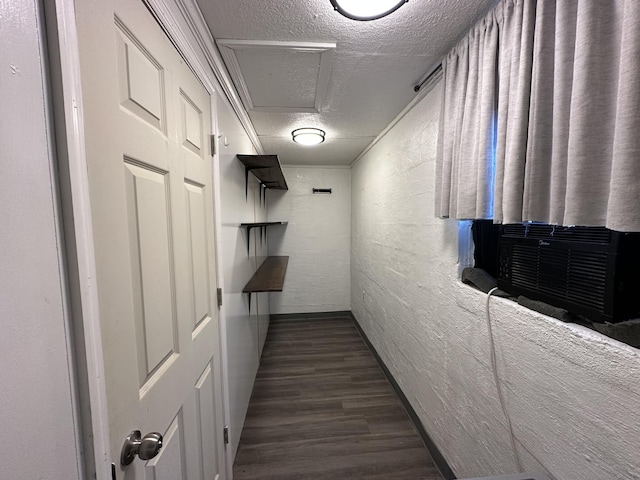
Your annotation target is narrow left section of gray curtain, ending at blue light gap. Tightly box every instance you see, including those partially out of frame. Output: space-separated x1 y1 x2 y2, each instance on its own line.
436 13 499 218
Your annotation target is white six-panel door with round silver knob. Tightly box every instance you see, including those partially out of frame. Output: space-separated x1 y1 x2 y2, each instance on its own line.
76 0 226 480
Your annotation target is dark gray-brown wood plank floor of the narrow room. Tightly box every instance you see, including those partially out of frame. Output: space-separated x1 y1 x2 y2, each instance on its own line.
233 317 442 480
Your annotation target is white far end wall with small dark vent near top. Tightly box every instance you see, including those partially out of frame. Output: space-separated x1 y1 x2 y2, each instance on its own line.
268 166 351 314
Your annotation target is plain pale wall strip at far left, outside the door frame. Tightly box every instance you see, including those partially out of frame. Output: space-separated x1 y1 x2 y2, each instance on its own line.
0 0 81 479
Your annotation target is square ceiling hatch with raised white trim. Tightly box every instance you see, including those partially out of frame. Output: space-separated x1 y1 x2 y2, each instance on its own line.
217 39 336 113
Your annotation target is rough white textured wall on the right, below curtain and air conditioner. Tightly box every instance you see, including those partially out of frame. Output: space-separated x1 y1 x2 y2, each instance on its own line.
351 85 640 480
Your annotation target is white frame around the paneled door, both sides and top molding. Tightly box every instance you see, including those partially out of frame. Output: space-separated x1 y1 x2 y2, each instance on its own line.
45 0 256 480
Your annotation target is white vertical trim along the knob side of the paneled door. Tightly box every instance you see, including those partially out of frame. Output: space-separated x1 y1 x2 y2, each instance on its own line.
50 0 111 480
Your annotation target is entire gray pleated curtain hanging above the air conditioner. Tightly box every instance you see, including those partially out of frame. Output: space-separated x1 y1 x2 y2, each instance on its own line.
436 0 640 231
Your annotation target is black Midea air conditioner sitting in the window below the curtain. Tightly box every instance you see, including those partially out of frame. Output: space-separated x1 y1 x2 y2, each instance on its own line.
498 223 640 322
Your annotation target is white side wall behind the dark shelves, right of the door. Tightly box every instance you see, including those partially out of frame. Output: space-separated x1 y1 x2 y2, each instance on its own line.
216 95 269 457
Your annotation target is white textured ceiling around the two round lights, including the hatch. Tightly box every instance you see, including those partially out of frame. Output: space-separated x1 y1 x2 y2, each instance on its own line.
198 0 495 165
